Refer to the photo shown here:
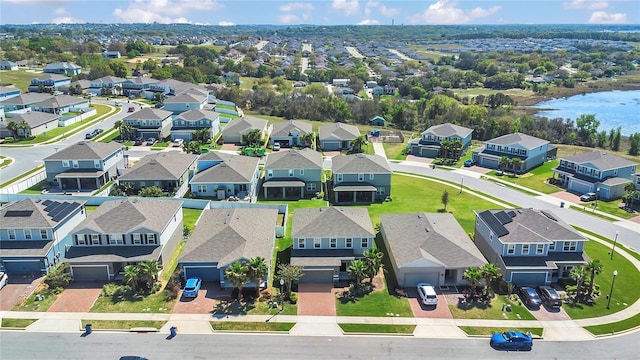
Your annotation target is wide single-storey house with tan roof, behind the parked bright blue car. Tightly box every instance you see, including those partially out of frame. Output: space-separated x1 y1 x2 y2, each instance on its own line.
178 208 278 288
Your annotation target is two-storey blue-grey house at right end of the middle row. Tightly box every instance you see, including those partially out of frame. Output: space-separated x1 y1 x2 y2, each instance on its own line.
331 154 392 204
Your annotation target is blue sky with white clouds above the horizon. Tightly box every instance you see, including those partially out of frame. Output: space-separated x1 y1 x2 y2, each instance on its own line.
0 0 640 25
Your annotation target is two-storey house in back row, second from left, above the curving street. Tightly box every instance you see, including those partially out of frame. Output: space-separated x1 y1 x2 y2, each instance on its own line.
171 109 220 141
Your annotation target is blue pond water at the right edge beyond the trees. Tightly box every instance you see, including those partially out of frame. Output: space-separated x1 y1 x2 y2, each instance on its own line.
534 90 640 136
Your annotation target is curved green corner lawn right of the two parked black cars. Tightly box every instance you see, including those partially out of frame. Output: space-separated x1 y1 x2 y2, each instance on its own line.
562 241 640 319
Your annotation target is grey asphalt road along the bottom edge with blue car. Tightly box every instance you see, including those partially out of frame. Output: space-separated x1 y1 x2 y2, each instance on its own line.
0 331 640 360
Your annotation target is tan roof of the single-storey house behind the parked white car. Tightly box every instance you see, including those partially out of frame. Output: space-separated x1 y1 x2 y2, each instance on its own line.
380 212 487 268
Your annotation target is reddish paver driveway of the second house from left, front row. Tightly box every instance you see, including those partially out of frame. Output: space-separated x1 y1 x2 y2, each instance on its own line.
49 281 105 312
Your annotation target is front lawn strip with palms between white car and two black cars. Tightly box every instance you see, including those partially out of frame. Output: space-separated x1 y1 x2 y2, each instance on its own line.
449 295 536 320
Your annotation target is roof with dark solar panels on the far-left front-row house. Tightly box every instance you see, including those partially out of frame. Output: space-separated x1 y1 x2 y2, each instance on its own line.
0 199 86 229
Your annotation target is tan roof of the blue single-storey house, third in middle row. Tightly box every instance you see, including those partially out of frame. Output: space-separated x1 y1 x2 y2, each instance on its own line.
191 155 260 184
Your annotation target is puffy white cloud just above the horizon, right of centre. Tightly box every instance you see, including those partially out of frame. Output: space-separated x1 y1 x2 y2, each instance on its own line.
407 0 501 24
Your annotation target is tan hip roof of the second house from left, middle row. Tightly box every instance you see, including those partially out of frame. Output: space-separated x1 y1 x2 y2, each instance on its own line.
120 151 198 181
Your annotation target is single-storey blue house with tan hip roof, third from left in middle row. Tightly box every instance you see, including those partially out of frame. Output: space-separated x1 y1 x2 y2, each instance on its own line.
190 151 260 200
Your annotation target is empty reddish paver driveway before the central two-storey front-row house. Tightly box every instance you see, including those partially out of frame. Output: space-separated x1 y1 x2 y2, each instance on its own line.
298 284 336 316
